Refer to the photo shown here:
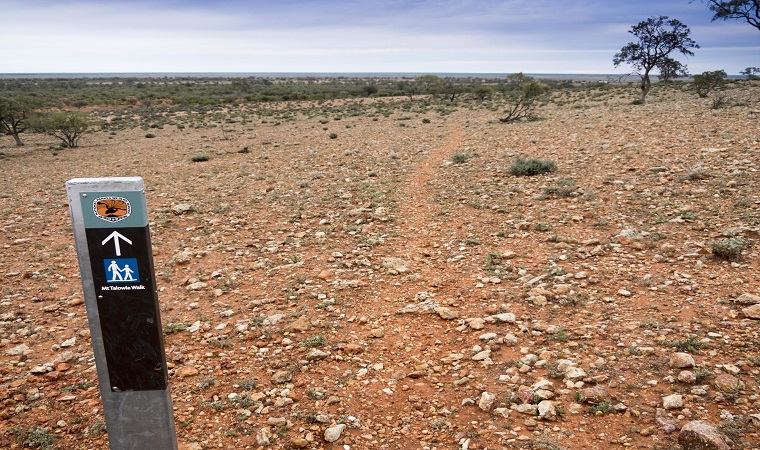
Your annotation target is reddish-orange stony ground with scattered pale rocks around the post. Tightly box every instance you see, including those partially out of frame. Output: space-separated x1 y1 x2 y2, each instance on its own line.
0 84 760 450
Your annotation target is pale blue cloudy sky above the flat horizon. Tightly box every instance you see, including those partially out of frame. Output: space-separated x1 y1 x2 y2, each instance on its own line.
0 0 760 74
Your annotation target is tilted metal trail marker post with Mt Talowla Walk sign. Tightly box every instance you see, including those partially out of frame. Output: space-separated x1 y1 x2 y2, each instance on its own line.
66 177 177 450
